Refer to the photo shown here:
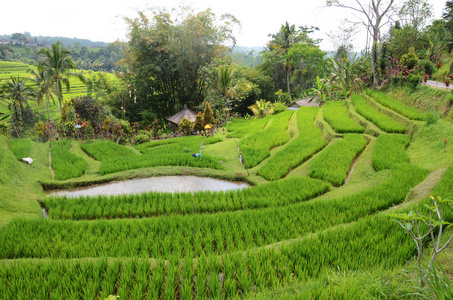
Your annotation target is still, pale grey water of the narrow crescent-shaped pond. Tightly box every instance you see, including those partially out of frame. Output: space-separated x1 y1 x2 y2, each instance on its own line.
49 176 249 197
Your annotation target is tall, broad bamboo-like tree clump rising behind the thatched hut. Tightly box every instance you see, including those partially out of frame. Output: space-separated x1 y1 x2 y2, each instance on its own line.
124 7 238 120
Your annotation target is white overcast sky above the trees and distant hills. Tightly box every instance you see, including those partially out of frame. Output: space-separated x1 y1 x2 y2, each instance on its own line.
0 0 446 50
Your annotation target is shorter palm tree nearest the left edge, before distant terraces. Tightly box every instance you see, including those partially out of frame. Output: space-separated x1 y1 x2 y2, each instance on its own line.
0 76 36 137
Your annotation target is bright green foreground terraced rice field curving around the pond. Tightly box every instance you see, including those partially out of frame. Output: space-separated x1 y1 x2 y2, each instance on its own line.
0 90 453 299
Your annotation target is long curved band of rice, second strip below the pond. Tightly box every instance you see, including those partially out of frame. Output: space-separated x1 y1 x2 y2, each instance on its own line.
0 164 426 259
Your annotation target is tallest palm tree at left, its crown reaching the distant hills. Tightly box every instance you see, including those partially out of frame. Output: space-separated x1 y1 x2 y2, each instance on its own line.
39 42 85 114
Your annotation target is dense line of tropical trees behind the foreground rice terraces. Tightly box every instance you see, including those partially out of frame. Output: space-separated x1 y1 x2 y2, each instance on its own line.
3 0 453 138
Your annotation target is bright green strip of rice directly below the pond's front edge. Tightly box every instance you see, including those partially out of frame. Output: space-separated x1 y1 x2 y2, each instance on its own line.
42 177 329 220
